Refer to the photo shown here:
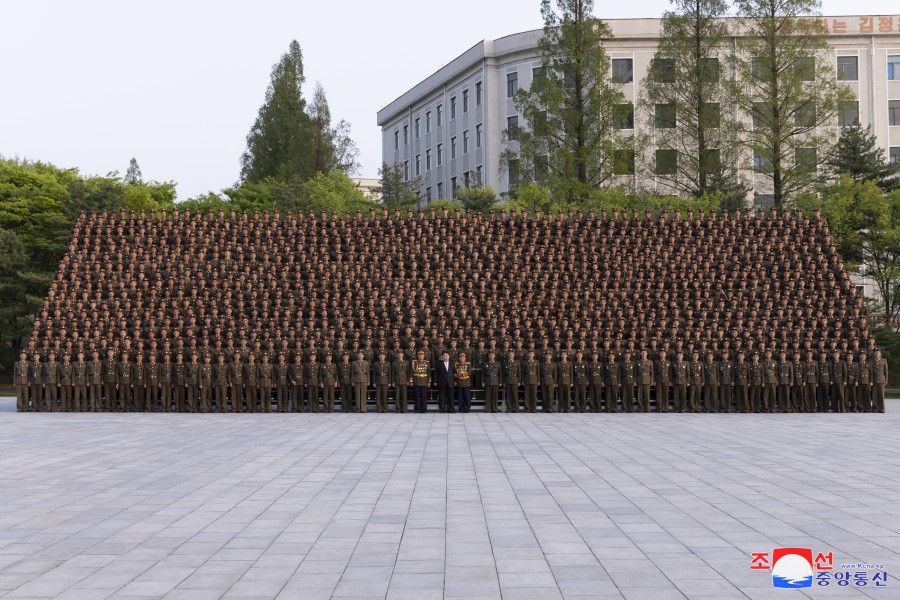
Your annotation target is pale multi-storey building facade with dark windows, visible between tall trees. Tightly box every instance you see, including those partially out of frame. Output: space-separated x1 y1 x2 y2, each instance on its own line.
378 15 900 209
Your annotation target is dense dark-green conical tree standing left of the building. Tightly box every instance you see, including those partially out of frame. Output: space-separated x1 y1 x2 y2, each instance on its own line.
241 40 315 183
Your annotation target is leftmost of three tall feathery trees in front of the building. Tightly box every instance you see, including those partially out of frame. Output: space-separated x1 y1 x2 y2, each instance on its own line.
501 0 635 202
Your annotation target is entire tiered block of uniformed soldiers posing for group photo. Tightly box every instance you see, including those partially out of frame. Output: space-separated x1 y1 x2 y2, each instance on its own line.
14 204 887 412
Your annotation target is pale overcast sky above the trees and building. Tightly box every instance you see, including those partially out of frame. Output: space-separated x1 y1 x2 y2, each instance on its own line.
0 0 884 200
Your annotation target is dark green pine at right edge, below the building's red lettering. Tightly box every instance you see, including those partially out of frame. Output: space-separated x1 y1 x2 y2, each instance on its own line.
826 123 900 190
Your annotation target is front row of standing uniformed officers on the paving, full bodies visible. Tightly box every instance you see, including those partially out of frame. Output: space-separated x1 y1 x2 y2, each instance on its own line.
14 350 888 413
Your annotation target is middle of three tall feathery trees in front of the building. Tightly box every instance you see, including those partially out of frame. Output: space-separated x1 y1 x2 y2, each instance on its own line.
640 0 746 197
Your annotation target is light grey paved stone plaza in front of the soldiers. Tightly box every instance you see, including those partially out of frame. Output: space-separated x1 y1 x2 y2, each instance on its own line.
0 399 900 600
